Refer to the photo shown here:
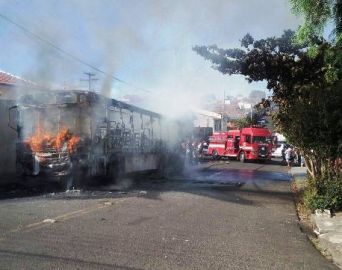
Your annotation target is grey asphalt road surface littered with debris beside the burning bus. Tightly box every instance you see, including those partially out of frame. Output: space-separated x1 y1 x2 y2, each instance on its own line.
0 161 337 270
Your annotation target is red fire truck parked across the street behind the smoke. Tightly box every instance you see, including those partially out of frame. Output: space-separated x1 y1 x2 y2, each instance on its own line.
208 126 273 162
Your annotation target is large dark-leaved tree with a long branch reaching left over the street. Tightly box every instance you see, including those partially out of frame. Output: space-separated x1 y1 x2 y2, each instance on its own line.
193 30 342 181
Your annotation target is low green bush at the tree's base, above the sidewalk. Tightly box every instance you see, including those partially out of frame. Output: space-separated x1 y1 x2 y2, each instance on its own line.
304 176 342 211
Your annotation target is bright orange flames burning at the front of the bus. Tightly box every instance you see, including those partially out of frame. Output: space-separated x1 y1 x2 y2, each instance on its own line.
28 128 80 153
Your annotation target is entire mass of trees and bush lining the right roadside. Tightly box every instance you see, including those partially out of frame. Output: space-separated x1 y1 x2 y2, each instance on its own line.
193 0 342 210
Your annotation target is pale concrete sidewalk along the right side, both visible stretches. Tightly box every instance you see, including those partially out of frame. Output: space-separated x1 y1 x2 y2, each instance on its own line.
289 167 342 269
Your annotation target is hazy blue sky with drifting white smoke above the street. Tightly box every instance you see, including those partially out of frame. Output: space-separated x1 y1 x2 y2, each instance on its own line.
0 0 301 114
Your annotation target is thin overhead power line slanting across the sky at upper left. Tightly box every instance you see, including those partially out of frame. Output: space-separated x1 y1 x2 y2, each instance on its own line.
0 13 151 93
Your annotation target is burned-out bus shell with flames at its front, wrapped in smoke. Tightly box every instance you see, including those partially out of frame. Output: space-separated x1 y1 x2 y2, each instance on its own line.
9 90 184 188
